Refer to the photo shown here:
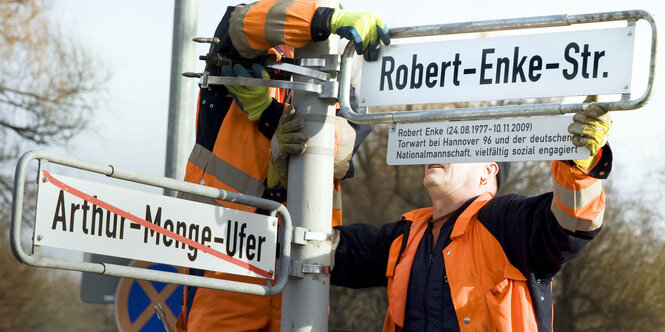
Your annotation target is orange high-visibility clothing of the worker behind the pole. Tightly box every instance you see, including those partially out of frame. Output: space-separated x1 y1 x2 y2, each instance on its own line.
177 0 358 331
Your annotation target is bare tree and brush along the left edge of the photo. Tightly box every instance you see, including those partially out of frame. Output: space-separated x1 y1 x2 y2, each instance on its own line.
0 0 115 331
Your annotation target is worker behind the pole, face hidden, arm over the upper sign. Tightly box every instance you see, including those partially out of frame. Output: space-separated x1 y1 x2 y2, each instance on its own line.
177 0 389 331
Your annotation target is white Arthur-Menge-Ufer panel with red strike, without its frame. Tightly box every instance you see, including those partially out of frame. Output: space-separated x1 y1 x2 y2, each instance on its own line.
34 172 277 279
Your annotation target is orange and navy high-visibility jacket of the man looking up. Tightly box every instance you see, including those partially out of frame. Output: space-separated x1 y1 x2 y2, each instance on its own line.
331 148 611 331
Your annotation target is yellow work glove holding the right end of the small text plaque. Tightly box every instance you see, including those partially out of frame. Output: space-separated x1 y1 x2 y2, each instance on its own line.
568 95 612 169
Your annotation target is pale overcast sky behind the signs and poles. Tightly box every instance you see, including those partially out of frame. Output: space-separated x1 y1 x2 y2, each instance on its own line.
51 0 665 205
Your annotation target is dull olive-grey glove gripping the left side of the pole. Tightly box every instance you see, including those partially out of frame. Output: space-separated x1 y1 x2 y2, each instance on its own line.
266 105 307 189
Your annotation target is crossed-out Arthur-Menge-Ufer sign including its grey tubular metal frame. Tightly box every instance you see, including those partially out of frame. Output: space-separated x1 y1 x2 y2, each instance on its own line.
11 151 293 295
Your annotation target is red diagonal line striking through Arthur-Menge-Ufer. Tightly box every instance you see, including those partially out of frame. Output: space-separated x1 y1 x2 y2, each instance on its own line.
43 171 272 279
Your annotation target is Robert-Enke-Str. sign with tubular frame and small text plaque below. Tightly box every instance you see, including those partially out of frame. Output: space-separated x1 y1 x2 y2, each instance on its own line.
339 10 656 165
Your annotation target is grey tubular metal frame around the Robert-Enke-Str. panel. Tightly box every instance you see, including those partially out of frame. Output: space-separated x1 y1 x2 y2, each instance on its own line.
339 10 657 124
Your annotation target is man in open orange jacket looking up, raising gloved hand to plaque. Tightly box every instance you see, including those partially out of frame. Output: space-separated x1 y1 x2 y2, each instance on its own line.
331 99 612 332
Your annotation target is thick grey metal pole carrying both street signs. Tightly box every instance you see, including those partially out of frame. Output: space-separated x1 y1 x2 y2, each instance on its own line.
281 0 339 331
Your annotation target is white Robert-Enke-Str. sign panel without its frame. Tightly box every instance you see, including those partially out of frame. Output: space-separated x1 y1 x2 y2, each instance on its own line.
360 26 635 106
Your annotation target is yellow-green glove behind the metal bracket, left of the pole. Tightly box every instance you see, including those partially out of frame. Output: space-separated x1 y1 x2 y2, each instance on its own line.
222 63 272 121
